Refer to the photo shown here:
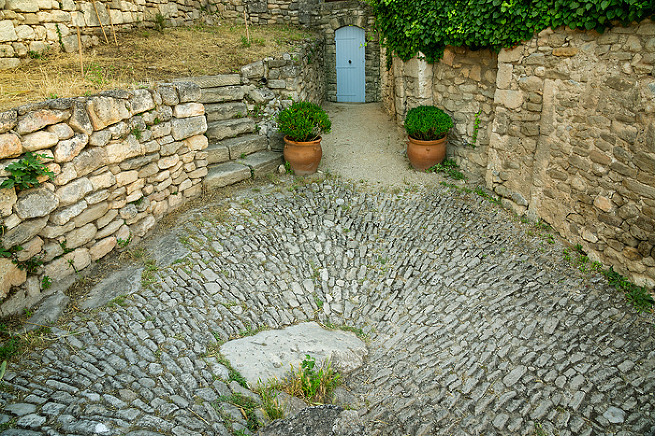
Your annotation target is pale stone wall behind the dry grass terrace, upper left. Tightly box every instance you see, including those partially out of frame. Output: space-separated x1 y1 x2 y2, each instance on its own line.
0 0 218 69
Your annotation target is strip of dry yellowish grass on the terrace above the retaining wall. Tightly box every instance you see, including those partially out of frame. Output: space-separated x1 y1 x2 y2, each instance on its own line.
0 21 313 110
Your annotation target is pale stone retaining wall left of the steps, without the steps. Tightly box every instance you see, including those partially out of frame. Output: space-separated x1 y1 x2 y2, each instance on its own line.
0 83 208 314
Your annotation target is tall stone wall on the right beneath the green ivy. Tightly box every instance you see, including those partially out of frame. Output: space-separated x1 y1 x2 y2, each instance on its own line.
384 21 655 286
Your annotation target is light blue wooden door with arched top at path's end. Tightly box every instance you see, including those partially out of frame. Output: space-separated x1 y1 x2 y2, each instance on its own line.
334 26 366 103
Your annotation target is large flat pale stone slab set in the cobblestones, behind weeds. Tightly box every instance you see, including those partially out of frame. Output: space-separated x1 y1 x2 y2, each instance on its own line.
221 322 368 387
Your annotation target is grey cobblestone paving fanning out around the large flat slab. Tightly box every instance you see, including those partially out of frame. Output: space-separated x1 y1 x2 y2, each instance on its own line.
0 181 655 436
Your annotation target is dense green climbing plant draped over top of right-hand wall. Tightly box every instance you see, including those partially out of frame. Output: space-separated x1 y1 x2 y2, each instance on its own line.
368 0 655 62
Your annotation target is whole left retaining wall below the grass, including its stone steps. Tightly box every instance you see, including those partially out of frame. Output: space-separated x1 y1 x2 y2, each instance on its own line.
0 40 325 316
